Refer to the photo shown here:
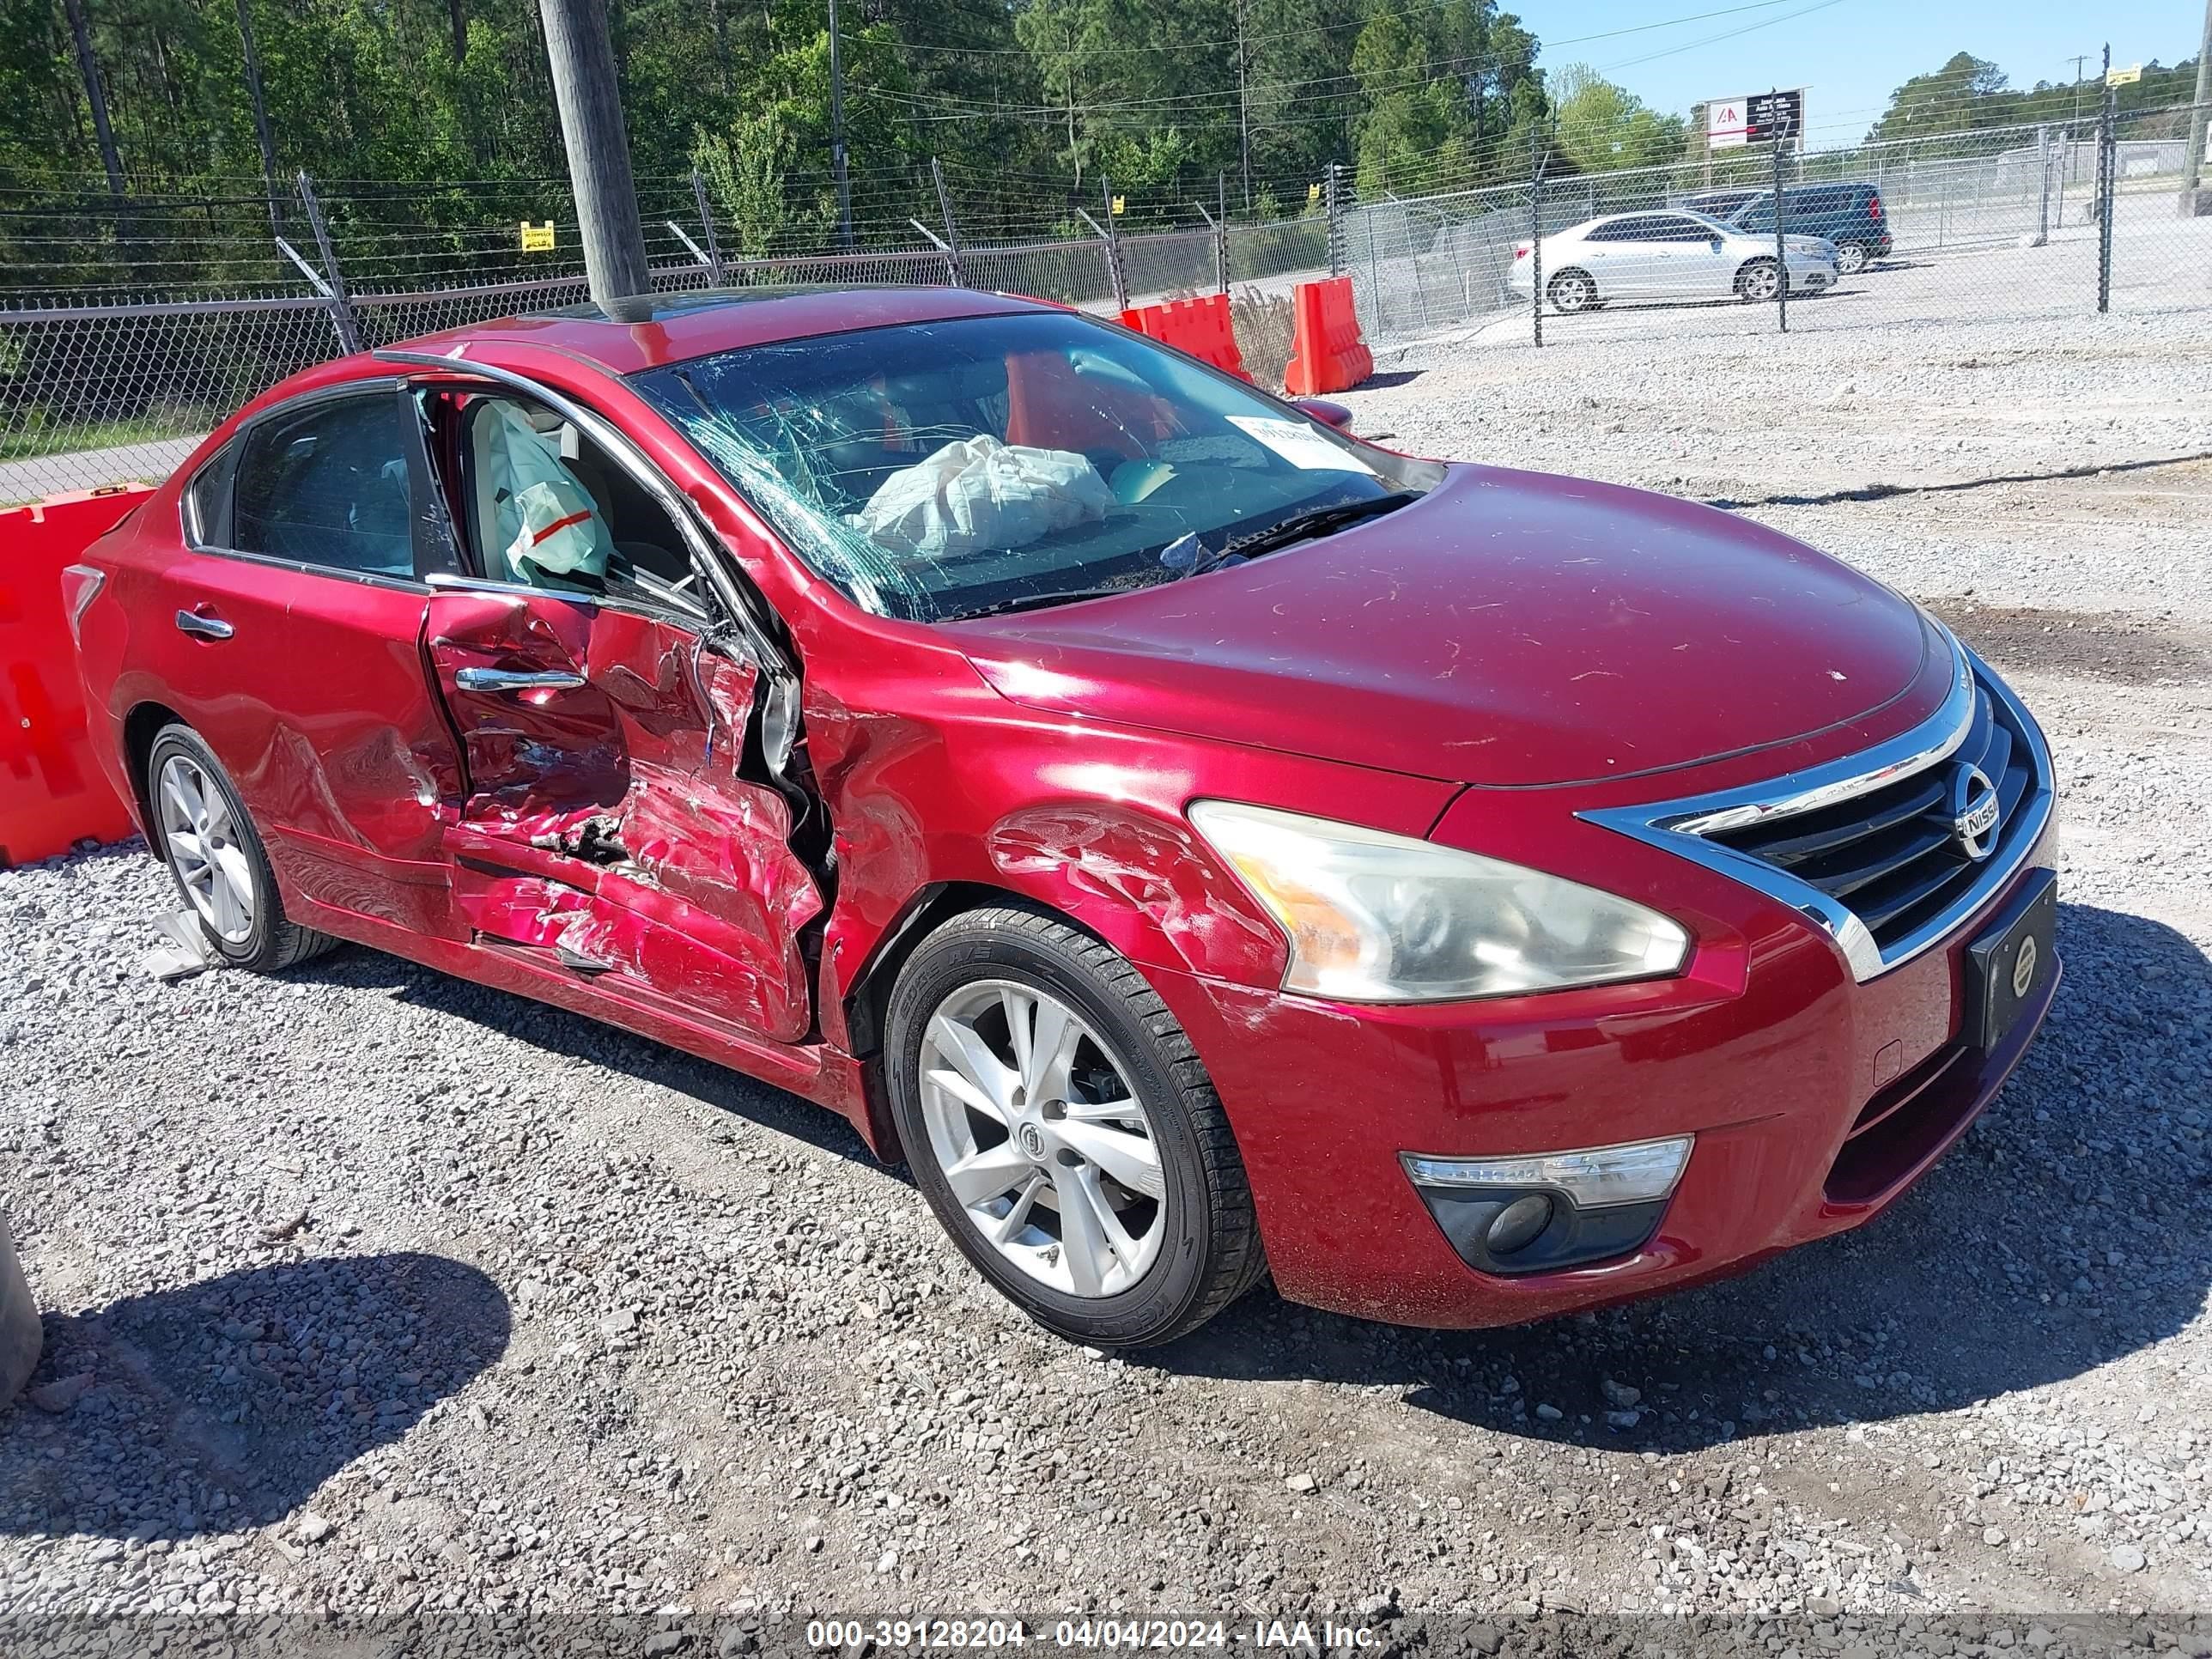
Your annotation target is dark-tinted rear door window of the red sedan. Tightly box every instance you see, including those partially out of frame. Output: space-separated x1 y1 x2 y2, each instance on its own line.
230 389 416 577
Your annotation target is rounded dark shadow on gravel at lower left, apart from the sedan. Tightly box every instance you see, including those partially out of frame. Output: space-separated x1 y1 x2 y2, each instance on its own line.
0 1252 511 1537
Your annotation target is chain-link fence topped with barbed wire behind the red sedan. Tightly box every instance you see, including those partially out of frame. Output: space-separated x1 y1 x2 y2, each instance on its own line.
0 106 2212 502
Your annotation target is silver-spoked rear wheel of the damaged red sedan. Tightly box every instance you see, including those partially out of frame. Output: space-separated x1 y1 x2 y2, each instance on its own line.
146 726 337 973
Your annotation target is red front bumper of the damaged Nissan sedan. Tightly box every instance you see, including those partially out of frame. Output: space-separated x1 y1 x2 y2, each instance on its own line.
1152 831 2059 1328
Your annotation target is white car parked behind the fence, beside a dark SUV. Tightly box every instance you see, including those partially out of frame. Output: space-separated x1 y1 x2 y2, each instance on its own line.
1506 208 1836 312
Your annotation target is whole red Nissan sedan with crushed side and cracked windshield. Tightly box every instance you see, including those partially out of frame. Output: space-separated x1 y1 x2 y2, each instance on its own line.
66 289 2057 1345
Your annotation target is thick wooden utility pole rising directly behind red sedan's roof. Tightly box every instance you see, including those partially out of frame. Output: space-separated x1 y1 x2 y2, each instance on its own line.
542 0 653 305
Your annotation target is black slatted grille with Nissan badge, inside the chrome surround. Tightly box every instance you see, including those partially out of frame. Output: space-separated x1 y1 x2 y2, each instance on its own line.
1708 677 2037 953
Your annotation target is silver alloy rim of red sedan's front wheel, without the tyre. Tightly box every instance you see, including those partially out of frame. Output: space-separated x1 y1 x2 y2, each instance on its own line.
921 980 1168 1298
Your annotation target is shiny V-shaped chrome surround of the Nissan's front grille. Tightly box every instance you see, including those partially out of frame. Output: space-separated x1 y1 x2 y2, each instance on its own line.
1577 619 2055 984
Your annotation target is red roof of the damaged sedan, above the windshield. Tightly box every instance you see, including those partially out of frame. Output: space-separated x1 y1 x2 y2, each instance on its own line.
392 285 1064 374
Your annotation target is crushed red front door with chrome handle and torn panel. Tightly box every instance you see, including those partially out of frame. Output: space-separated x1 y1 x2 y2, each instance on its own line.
422 586 821 1042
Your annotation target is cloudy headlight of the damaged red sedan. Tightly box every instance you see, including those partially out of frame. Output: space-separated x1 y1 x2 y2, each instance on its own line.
1190 801 1690 1002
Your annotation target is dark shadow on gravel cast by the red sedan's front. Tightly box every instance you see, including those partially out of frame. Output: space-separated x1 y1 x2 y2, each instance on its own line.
1130 905 2212 1451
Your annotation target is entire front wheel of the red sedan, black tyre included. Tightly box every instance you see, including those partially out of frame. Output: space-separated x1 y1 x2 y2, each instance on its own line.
884 909 1263 1347
